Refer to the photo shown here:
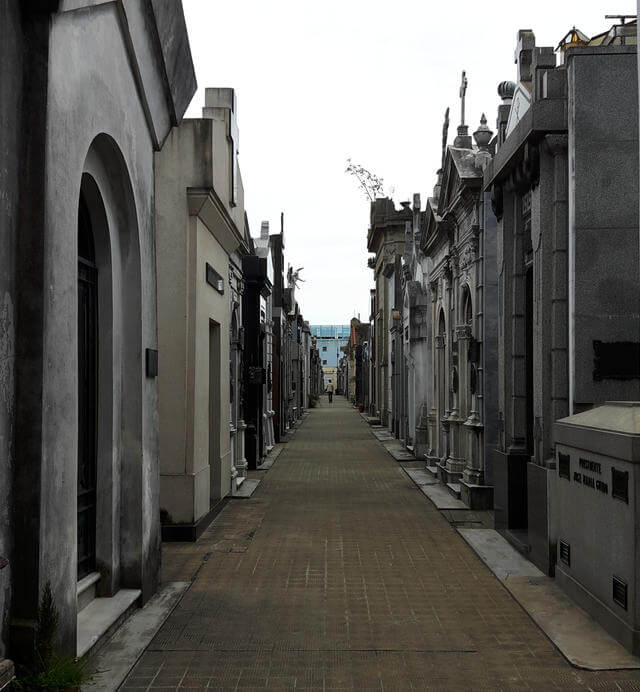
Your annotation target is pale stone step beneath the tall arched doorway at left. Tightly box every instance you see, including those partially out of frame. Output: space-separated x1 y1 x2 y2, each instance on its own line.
76 589 142 658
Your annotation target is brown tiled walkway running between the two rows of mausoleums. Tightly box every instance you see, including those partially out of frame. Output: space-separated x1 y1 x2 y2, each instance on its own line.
122 397 640 690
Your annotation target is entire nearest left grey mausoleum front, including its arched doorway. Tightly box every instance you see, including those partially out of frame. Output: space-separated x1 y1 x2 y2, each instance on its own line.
0 0 195 672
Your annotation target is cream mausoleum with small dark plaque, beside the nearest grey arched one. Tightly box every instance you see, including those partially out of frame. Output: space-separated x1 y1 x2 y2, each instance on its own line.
155 113 244 524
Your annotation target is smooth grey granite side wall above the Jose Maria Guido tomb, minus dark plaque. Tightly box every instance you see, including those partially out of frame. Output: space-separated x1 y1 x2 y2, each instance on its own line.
567 46 640 405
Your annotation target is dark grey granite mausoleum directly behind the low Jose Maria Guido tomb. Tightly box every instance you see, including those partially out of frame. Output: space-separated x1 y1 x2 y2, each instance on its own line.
484 31 640 573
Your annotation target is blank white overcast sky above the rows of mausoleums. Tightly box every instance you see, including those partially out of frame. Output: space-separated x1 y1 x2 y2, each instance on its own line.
183 0 635 324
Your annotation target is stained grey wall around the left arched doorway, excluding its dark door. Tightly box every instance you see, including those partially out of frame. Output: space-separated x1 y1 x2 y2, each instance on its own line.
5 0 195 657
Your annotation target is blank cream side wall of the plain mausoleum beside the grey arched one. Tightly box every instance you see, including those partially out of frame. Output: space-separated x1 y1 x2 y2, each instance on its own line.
155 125 198 523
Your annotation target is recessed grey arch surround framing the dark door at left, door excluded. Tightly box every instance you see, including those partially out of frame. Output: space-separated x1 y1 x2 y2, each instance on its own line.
78 134 142 596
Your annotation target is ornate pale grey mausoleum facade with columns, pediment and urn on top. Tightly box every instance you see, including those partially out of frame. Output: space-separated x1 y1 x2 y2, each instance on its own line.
421 111 497 509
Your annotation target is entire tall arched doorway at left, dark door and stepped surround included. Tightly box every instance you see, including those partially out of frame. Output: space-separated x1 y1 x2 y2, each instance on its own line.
77 135 144 607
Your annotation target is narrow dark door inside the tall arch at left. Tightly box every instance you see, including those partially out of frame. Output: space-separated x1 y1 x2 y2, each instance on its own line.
77 193 98 579
